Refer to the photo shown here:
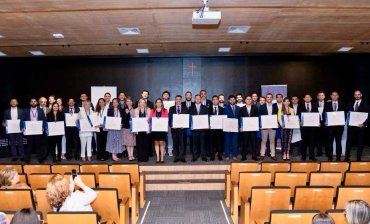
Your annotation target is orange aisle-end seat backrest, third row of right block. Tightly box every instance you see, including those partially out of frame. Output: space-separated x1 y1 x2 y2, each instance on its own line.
249 187 290 223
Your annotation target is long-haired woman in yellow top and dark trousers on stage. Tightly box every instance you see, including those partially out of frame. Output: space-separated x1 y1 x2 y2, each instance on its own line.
278 97 295 161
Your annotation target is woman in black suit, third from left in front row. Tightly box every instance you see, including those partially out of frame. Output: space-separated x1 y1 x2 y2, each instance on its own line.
46 102 64 163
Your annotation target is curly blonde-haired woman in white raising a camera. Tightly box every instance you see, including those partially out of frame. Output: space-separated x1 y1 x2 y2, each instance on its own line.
46 174 96 212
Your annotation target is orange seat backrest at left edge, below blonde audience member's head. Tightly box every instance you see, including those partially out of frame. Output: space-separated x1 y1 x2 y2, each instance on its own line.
0 189 35 211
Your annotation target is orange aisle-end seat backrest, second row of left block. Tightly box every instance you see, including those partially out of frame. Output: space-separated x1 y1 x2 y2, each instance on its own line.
99 173 131 199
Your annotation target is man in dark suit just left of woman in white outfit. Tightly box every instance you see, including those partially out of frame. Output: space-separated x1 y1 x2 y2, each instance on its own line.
63 98 81 160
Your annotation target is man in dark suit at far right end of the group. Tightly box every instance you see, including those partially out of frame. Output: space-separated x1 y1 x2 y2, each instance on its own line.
344 90 370 161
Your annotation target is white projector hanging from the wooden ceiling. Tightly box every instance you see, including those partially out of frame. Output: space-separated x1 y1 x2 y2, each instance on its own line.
192 0 221 25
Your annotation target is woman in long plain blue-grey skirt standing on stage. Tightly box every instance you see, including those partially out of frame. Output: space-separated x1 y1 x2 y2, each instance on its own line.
106 98 124 161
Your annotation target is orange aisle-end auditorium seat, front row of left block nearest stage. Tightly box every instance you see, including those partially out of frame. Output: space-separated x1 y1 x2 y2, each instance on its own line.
111 163 145 208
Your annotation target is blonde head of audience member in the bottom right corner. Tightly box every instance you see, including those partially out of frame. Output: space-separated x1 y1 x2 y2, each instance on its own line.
345 200 370 224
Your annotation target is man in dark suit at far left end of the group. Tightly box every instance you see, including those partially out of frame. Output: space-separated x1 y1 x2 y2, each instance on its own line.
3 98 24 162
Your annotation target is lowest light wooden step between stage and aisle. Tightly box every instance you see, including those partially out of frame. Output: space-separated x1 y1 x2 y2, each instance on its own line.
145 179 225 191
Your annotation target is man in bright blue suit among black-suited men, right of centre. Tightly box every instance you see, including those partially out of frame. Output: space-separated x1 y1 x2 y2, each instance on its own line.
224 95 240 161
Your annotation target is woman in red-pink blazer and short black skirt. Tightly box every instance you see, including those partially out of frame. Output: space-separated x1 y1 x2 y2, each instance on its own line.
149 98 168 163
